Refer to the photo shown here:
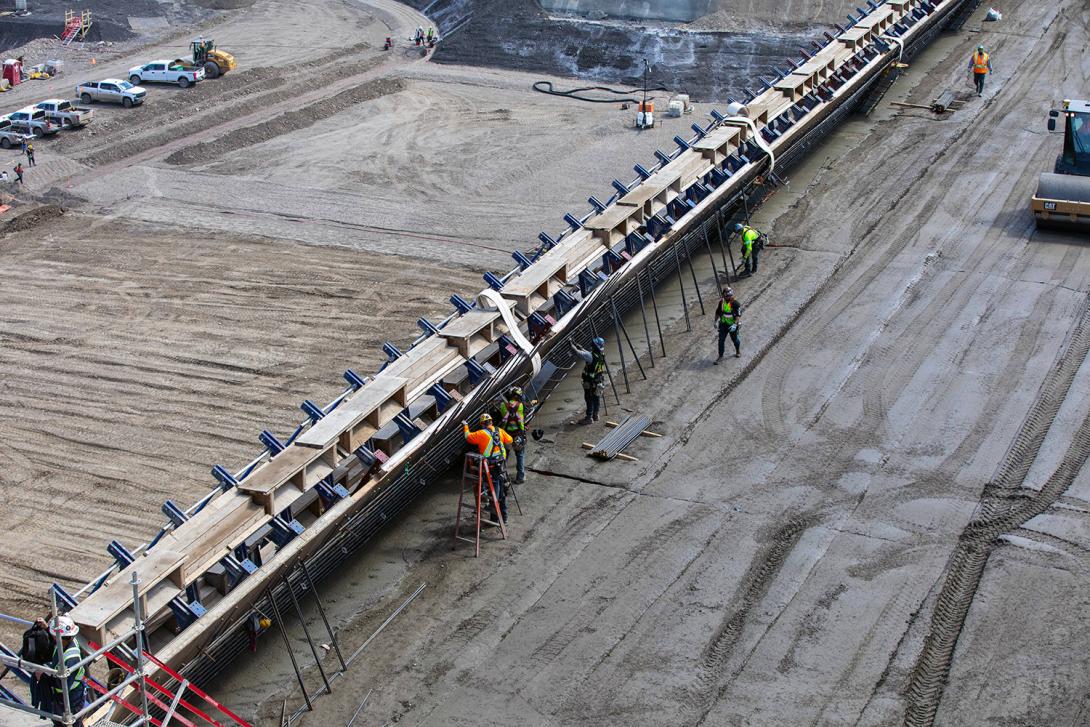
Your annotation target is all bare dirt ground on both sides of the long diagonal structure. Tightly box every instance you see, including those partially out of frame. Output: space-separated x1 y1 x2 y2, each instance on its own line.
0 0 1090 725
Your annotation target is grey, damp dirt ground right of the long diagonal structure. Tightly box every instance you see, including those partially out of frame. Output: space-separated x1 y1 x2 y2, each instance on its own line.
202 2 1090 725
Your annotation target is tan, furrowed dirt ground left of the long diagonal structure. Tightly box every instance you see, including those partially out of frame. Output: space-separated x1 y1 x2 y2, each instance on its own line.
0 0 767 643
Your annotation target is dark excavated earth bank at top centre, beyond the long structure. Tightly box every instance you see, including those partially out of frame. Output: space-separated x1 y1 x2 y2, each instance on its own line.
409 0 853 101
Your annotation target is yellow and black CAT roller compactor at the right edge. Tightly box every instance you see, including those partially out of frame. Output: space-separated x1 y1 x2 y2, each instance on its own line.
1031 100 1090 231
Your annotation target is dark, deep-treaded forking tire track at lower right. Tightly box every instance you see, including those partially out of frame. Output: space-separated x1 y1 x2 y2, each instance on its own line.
905 299 1090 727
